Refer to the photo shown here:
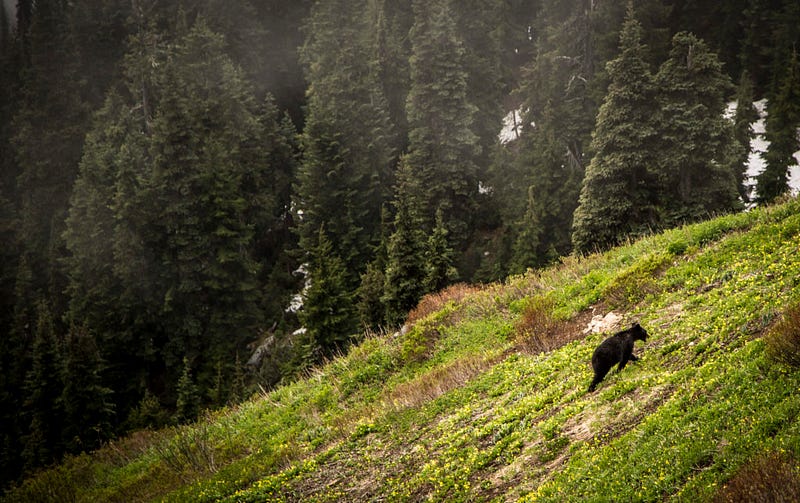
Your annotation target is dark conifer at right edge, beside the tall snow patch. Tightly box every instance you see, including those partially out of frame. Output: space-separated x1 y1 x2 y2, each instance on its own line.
756 51 800 204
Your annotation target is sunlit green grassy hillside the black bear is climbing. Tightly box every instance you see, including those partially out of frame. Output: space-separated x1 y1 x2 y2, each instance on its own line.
7 200 800 502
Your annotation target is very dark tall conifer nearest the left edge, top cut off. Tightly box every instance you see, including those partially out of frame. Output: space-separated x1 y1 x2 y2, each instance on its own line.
13 0 90 312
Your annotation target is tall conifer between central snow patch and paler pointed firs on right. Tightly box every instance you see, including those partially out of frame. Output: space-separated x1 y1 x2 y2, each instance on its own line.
507 0 596 272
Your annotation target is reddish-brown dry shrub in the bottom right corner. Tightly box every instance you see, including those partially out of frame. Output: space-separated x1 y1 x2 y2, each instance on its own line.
714 452 800 503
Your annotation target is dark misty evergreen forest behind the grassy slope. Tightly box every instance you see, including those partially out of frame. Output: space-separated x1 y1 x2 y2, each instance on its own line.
0 0 800 486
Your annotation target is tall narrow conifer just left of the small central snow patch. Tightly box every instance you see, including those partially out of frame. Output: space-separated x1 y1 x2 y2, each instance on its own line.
402 0 481 251
